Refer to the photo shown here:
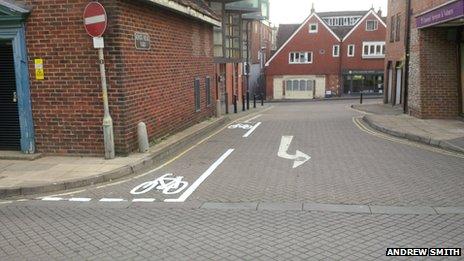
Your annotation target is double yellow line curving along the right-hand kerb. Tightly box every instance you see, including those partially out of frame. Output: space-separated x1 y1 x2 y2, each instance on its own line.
353 117 464 159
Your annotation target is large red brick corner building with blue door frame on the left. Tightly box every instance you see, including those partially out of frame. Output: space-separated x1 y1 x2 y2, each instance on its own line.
0 0 220 155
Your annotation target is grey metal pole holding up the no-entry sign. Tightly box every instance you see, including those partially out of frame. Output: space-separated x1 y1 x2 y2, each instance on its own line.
98 42 115 159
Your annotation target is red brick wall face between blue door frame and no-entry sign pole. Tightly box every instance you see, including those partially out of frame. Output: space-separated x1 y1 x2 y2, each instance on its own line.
26 0 114 154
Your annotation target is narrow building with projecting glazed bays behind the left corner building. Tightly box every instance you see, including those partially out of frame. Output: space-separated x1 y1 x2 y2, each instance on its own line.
207 0 270 113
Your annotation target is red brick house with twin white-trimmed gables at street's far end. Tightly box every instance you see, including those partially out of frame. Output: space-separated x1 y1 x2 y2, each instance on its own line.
266 6 386 99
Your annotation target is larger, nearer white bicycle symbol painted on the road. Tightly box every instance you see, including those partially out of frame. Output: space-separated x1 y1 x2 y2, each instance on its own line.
130 173 188 195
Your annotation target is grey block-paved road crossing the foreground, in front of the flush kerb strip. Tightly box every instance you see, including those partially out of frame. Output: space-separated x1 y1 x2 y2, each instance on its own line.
0 203 464 260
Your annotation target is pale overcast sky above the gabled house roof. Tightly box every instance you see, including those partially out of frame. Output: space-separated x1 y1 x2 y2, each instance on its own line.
271 0 388 25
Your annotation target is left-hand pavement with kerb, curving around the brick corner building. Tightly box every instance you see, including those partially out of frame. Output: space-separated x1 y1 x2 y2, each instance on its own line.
0 105 268 198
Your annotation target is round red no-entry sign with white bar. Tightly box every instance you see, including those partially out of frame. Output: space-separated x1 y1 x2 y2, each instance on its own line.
84 2 108 37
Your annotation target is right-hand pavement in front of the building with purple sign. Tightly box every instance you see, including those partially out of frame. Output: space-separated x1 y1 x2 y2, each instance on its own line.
353 103 464 153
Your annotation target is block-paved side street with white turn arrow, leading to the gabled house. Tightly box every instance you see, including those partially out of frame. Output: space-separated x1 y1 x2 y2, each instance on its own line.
30 101 464 206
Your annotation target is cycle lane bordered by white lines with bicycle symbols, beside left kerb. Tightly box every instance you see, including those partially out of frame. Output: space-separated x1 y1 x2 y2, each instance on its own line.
37 109 272 203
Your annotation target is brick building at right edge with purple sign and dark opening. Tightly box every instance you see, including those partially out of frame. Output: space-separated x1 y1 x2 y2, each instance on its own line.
384 0 464 119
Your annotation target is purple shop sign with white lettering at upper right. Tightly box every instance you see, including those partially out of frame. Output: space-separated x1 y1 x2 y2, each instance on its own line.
416 0 464 28
